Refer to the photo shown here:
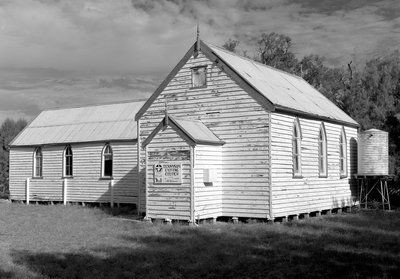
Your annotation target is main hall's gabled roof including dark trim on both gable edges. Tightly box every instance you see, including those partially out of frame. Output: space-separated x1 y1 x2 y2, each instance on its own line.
136 41 359 127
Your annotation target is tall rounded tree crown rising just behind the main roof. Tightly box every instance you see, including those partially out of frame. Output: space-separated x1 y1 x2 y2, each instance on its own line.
257 32 298 72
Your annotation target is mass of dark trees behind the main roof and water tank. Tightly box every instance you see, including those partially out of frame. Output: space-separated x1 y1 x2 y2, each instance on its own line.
224 33 400 184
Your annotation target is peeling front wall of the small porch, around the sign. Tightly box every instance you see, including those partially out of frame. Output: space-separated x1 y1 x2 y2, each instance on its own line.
146 128 191 221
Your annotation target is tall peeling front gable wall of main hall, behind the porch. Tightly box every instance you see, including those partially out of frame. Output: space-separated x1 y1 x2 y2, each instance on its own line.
140 53 269 218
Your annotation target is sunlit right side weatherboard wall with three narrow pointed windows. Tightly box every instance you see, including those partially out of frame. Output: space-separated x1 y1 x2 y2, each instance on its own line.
271 113 357 217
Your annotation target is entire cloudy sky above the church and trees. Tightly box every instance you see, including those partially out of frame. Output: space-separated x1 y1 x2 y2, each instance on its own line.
0 0 400 121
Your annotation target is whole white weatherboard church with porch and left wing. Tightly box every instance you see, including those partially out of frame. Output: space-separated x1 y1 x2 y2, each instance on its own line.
10 40 358 222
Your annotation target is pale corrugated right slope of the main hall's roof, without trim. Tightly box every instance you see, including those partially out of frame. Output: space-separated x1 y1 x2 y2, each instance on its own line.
205 43 358 125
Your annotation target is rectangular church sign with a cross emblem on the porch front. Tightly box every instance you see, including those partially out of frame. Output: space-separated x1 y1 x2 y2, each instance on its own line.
154 162 182 184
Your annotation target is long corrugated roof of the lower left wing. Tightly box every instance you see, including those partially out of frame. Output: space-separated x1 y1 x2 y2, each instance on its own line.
10 101 144 146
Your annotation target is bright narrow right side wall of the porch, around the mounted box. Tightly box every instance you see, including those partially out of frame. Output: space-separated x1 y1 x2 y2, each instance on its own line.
194 145 222 219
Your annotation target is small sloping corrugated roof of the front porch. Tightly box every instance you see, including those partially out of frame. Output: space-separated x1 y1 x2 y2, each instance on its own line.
170 116 224 144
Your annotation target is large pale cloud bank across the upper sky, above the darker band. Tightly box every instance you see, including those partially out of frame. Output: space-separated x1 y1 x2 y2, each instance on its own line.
0 0 399 73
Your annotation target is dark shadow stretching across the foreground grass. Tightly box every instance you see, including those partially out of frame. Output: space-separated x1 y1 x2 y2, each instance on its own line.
12 214 400 278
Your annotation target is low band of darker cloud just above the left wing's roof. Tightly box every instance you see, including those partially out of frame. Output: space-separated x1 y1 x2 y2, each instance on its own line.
0 69 161 123
